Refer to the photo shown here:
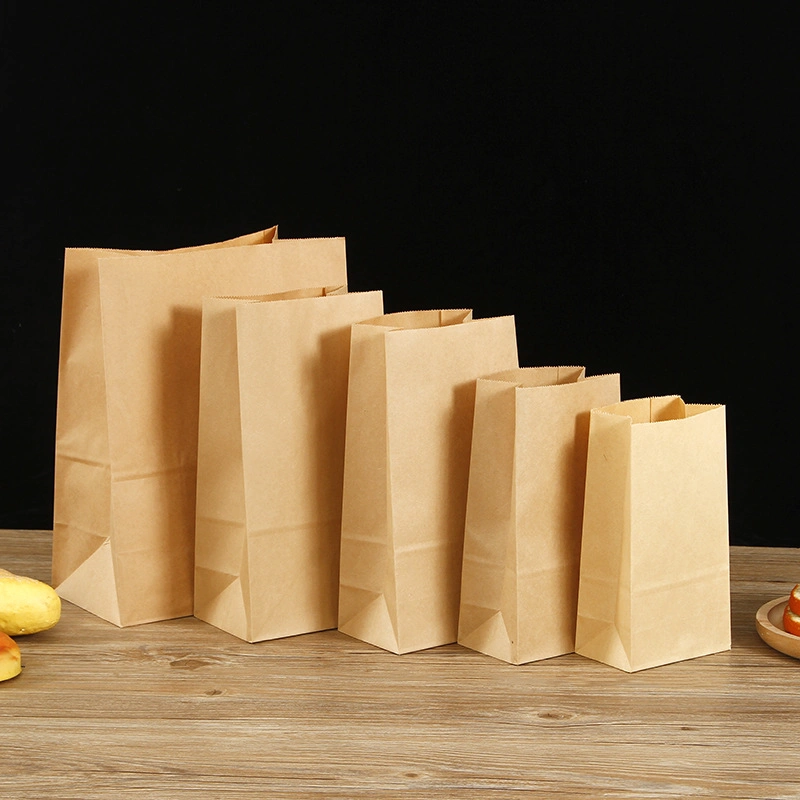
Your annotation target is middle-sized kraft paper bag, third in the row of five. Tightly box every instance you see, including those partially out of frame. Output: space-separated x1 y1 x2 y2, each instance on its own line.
338 309 517 653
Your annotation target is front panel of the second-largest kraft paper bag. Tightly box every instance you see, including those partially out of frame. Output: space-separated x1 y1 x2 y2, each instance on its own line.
231 292 383 641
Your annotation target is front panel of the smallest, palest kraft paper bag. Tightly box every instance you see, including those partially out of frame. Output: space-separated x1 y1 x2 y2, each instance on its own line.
631 406 730 669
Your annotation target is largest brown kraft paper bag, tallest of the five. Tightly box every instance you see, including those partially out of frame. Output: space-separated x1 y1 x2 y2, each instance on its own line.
53 228 346 626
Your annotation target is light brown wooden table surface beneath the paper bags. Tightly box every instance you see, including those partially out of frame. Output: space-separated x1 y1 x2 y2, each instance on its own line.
0 531 800 800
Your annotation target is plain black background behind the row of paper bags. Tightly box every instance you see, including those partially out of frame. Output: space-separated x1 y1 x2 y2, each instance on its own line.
0 2 800 546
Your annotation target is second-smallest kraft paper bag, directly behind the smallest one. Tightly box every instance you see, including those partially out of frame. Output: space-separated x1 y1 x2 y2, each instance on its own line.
458 367 619 664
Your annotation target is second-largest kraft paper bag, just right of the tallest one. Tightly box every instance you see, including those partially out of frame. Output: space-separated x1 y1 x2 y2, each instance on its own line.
194 287 383 642
